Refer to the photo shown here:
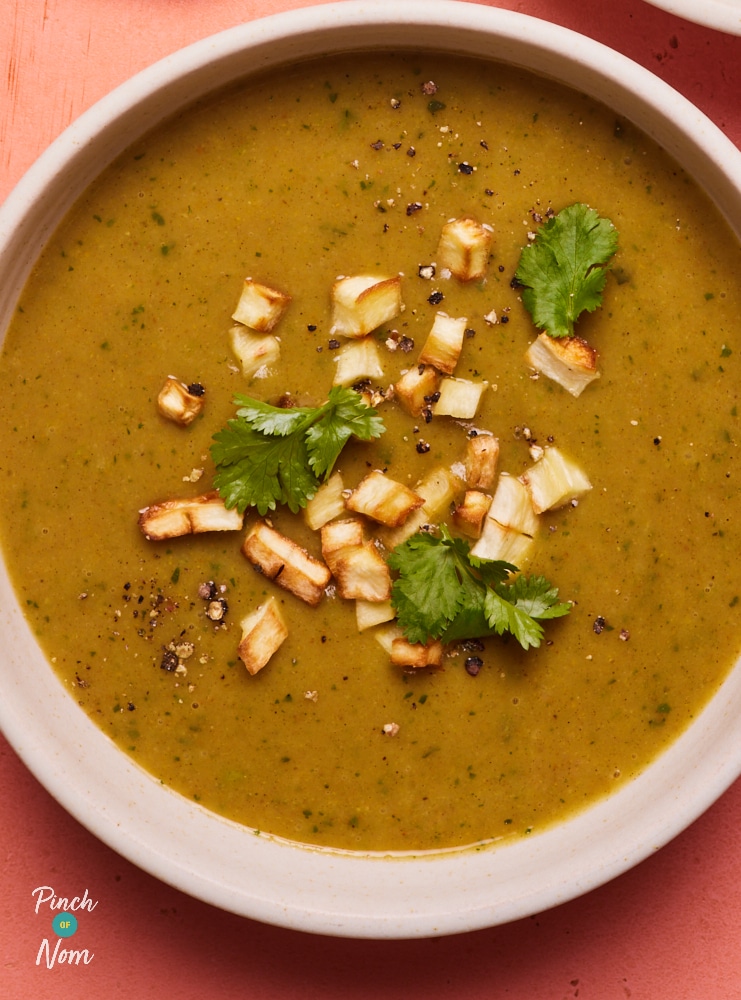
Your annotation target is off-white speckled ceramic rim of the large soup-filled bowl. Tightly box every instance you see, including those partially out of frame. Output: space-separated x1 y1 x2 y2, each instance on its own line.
0 0 741 938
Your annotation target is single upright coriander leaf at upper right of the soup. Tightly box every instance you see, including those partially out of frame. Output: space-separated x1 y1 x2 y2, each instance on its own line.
515 204 618 337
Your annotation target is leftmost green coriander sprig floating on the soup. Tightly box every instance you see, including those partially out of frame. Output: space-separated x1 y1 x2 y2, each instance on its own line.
211 386 385 514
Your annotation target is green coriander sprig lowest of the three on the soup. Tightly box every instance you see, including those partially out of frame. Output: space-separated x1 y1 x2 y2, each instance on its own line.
388 526 571 649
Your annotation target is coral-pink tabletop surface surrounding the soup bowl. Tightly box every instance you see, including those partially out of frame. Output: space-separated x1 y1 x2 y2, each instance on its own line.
0 0 741 1000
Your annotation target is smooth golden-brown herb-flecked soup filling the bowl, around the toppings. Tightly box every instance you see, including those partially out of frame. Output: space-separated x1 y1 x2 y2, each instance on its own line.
0 54 741 850
